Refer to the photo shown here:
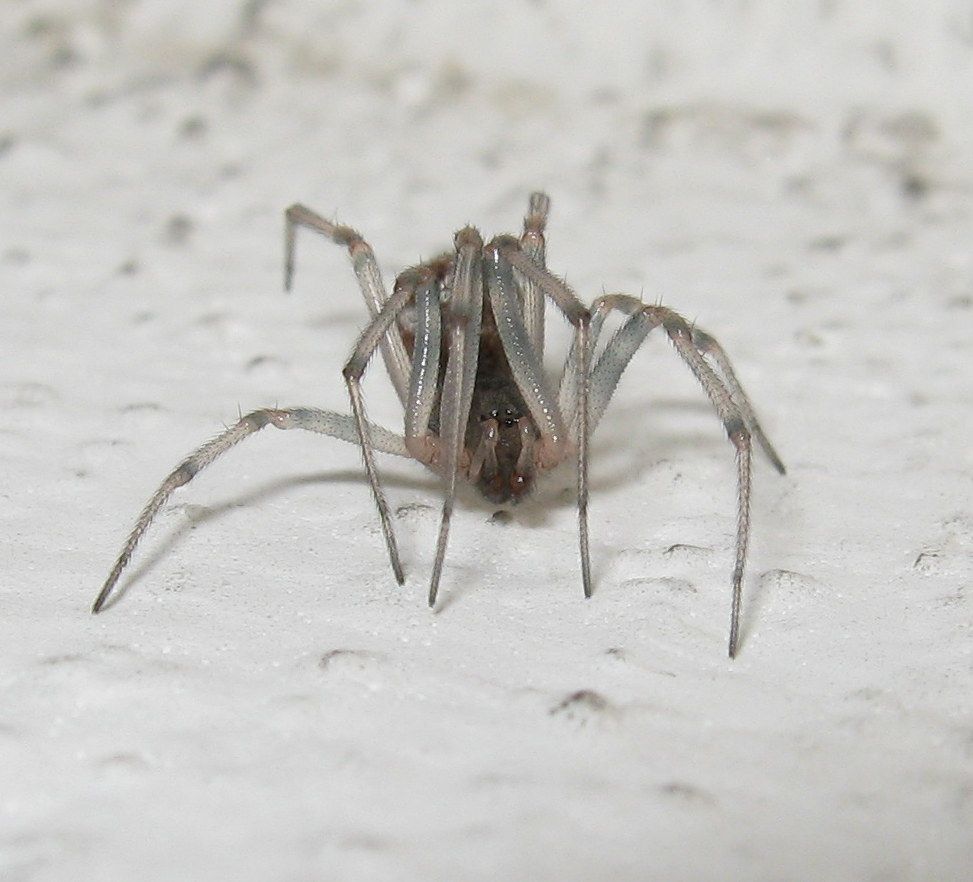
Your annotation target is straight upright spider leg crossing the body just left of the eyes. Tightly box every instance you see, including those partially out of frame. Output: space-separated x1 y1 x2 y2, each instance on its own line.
429 227 483 606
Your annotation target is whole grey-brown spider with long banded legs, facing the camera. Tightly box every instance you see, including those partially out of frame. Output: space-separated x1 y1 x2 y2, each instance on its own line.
92 193 784 658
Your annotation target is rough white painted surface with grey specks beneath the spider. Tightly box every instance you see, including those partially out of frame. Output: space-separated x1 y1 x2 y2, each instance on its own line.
0 0 973 882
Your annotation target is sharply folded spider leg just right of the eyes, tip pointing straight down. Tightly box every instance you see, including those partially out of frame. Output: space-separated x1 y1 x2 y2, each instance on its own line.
486 236 592 597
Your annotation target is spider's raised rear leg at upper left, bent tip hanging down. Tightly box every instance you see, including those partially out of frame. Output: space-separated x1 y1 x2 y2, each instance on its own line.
284 204 409 405
